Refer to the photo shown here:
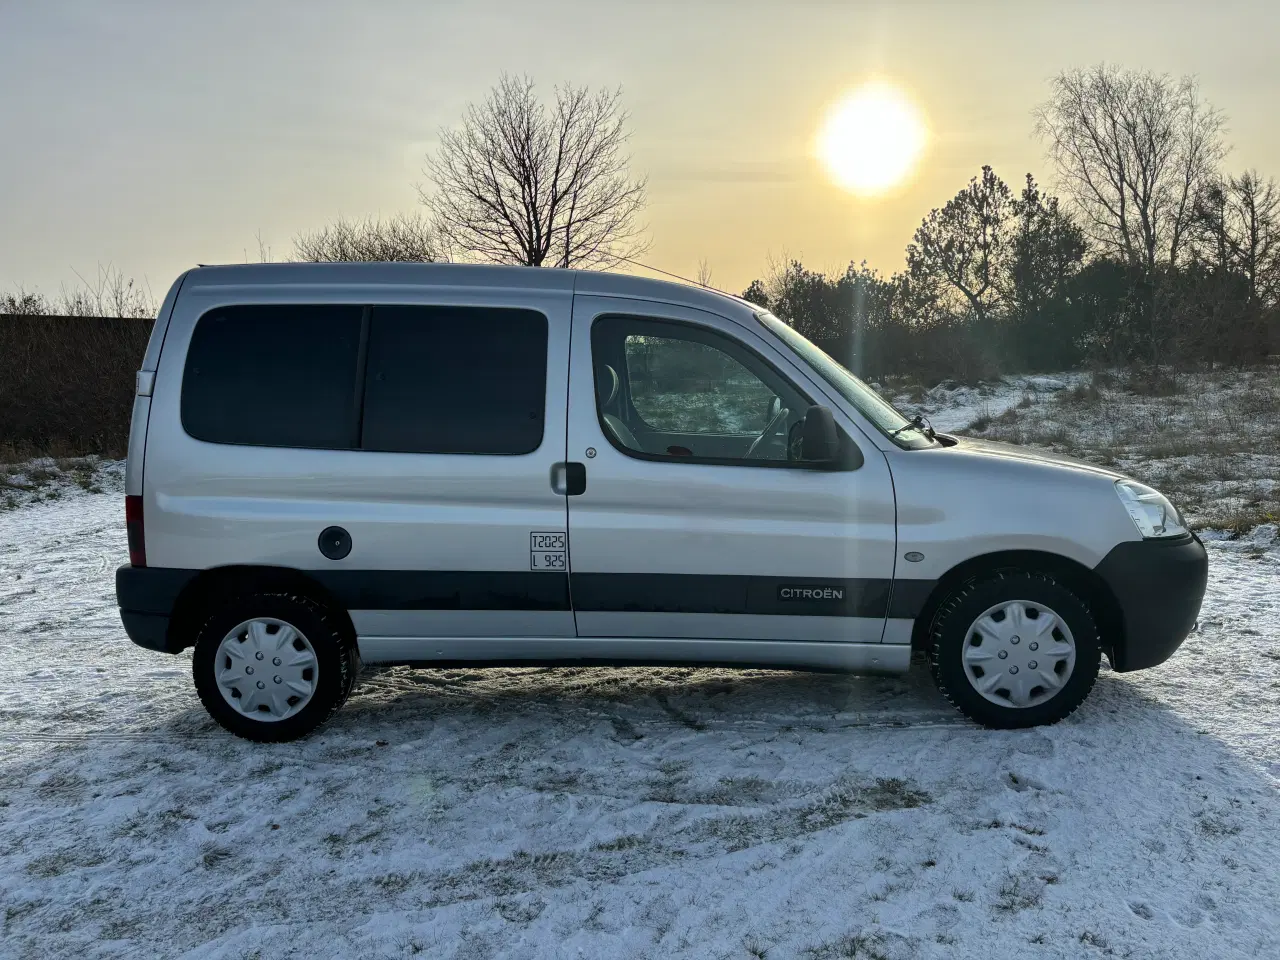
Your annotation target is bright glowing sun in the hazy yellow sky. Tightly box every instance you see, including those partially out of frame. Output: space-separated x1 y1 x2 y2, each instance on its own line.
817 83 928 196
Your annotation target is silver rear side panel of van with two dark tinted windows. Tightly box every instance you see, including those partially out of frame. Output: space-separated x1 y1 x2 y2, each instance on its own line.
146 288 573 659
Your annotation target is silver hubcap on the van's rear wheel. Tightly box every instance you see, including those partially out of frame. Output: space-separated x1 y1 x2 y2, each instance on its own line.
214 617 319 723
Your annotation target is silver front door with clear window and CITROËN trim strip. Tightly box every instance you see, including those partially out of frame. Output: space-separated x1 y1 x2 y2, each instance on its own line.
568 296 896 643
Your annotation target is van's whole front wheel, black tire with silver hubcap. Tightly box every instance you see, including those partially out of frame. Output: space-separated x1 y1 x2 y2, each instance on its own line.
929 571 1102 730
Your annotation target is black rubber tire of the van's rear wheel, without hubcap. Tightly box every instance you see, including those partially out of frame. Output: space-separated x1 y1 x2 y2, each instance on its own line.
191 593 360 744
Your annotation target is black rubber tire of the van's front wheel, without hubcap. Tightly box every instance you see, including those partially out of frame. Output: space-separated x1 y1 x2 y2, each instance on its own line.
929 570 1102 730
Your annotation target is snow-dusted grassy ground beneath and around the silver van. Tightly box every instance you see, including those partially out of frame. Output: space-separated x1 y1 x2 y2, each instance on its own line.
0 387 1280 960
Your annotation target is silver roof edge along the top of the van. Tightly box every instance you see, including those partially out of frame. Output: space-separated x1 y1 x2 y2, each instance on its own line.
184 262 758 316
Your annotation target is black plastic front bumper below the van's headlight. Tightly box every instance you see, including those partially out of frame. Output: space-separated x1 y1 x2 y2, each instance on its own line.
1094 534 1208 672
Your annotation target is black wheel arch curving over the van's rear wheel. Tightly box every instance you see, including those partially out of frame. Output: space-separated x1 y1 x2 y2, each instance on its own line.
165 564 356 653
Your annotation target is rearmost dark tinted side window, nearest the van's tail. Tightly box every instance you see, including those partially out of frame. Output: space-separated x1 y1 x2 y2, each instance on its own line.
182 305 364 449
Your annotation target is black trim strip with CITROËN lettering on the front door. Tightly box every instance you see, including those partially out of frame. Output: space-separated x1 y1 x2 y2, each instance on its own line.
571 573 892 617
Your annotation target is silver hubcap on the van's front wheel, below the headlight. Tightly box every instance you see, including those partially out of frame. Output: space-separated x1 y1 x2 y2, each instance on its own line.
960 600 1075 708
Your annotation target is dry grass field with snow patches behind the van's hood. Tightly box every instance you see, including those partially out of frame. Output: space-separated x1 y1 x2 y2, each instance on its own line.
963 366 1280 532
